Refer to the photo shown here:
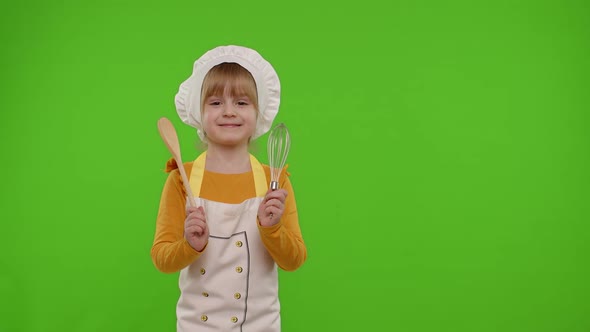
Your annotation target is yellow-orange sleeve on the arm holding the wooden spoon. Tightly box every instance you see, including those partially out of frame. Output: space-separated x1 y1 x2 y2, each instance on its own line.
151 163 200 273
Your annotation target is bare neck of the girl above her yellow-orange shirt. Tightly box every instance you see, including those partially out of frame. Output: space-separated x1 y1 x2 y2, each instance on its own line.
205 145 251 174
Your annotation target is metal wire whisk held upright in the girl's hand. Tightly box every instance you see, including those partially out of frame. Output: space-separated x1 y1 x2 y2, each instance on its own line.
267 123 291 190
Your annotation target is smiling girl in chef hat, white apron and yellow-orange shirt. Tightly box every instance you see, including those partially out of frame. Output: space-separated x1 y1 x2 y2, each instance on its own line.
151 46 307 332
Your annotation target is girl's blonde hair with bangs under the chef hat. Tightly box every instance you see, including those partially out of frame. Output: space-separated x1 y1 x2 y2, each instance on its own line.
201 62 258 114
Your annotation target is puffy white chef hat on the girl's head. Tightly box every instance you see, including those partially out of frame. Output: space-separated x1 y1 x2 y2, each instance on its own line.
174 45 281 141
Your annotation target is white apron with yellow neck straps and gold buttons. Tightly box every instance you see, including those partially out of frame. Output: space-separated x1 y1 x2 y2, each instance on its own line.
176 153 281 332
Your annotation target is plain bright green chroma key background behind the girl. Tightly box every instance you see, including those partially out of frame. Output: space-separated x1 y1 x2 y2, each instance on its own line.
0 0 590 332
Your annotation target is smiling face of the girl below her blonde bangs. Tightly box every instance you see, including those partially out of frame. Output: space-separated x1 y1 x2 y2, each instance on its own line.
203 93 257 146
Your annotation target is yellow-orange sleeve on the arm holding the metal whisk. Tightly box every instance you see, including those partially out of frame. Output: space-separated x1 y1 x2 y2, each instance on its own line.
258 171 307 271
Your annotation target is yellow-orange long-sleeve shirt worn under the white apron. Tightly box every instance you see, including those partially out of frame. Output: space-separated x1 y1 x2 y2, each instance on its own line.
151 159 307 273
